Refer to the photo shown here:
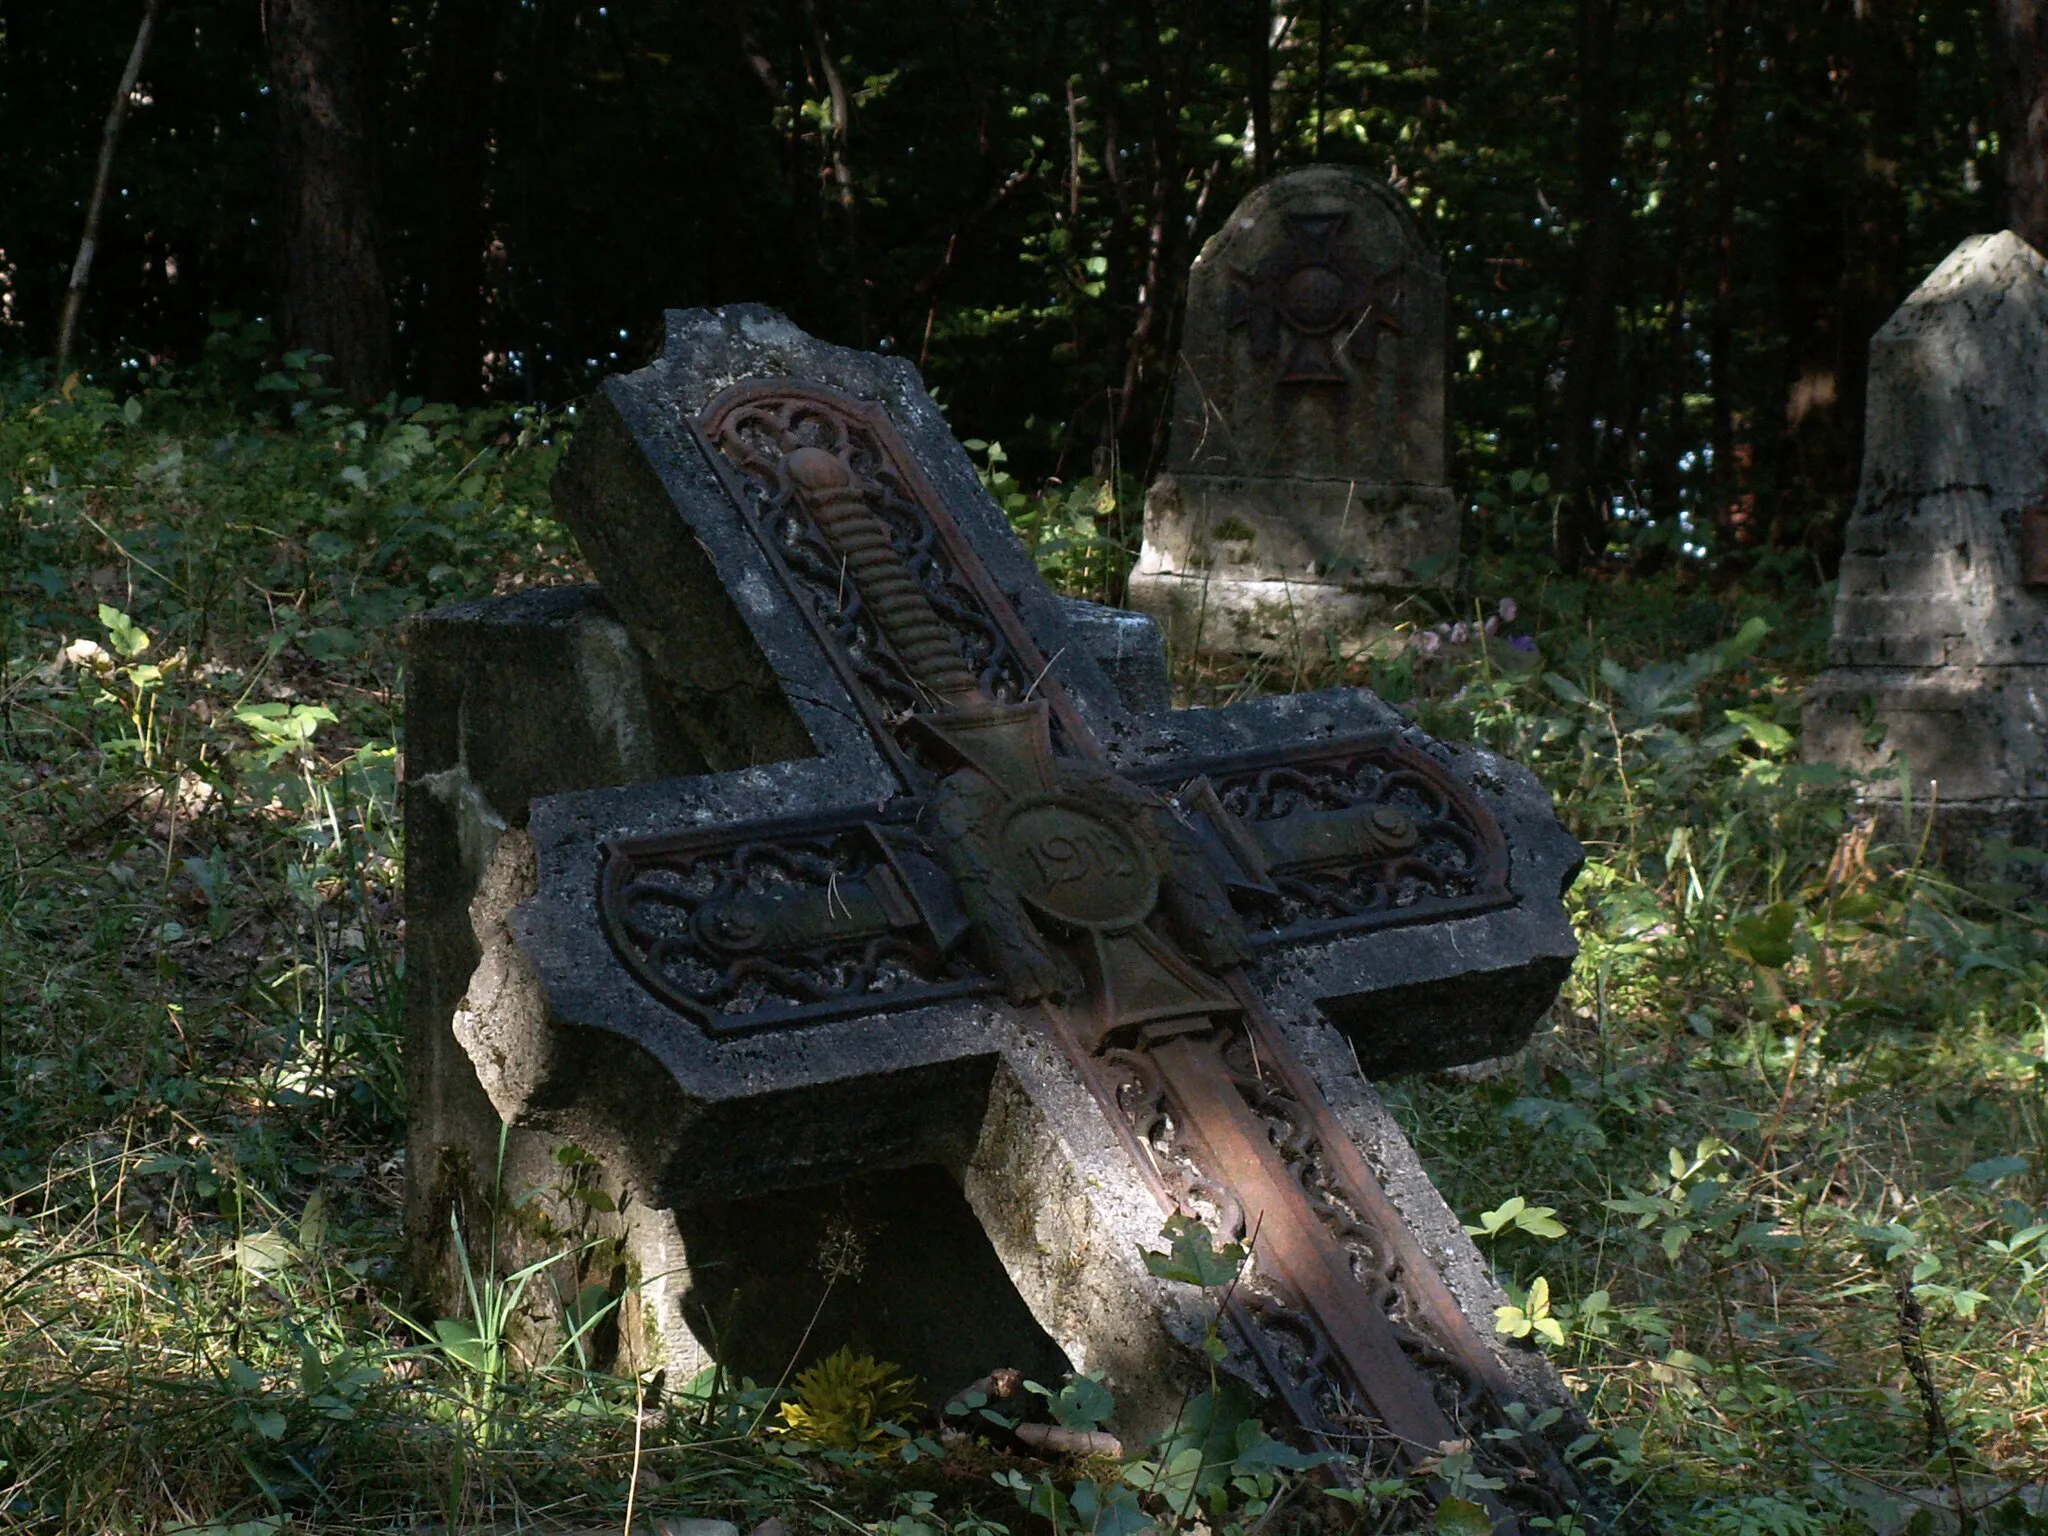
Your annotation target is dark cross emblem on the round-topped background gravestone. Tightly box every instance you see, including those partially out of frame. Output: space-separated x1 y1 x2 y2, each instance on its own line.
1225 209 1403 385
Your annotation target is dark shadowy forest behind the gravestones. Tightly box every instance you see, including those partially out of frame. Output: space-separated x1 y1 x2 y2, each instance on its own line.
0 0 2042 569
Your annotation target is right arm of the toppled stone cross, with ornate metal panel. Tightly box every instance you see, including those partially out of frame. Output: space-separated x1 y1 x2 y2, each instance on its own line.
1124 688 1583 1075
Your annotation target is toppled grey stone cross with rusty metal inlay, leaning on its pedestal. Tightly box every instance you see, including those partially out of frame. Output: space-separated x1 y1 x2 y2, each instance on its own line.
414 307 1579 1528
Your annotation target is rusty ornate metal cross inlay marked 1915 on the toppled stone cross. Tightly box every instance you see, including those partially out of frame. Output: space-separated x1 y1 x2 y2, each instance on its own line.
598 381 1577 1530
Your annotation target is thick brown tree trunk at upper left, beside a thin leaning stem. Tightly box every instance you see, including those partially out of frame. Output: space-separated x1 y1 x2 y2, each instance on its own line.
262 0 393 406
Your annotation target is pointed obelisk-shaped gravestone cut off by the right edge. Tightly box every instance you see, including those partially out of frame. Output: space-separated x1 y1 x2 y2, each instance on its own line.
1806 231 2048 895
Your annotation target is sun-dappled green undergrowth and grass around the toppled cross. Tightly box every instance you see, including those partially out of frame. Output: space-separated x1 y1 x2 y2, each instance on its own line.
0 346 2048 1536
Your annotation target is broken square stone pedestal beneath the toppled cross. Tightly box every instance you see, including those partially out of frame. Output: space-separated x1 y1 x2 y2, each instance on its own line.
406 586 1167 1391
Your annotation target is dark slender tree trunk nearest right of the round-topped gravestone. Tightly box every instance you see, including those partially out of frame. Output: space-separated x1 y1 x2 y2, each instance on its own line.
1556 0 1626 571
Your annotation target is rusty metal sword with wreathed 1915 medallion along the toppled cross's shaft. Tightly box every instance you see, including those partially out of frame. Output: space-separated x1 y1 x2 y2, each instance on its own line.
675 376 1563 1530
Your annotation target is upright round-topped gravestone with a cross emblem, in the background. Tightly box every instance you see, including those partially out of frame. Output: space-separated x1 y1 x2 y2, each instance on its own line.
1130 166 1458 655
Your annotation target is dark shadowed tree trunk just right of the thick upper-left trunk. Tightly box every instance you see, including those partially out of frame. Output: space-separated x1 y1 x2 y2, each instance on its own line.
418 0 506 406
